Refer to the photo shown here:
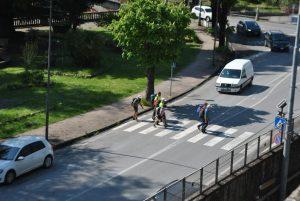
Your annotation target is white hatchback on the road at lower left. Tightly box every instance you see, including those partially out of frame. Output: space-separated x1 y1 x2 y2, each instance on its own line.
0 136 54 184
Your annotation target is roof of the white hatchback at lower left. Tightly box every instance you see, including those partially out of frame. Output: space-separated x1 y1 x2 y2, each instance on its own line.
1 135 45 148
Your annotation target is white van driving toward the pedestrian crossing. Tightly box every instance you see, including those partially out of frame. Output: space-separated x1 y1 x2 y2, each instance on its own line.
216 59 254 93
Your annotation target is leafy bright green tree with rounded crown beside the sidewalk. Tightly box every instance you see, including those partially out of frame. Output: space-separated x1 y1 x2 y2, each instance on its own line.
111 0 190 100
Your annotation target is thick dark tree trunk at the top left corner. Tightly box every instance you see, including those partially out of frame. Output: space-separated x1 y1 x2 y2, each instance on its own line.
0 0 15 38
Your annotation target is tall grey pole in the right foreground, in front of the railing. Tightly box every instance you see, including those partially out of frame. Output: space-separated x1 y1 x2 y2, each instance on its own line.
280 1 300 201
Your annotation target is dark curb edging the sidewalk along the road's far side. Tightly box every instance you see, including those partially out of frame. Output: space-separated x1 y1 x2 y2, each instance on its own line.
52 68 220 150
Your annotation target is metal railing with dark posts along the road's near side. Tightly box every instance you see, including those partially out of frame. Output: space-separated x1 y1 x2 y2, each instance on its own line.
144 117 300 201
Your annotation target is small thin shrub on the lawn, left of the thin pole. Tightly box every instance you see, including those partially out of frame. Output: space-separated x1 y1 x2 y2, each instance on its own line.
22 42 38 71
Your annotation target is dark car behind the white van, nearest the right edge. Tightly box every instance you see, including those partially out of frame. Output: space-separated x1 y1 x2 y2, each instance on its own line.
265 31 290 52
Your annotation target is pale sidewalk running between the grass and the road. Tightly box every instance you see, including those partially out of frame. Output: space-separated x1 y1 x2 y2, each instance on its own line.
20 21 218 146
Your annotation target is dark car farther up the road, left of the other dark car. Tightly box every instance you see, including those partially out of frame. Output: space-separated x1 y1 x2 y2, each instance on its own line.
236 20 261 36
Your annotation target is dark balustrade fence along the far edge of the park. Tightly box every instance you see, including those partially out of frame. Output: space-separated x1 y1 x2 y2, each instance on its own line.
14 10 118 28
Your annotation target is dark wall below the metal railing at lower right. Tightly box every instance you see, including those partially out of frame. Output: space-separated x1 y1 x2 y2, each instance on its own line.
190 138 300 201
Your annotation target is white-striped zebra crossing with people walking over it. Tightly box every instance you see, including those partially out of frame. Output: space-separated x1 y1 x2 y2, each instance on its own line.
113 118 254 151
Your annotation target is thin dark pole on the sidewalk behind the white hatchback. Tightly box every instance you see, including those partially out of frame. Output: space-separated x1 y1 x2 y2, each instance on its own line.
45 0 52 140
